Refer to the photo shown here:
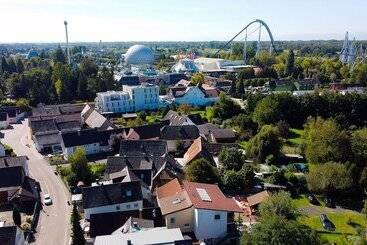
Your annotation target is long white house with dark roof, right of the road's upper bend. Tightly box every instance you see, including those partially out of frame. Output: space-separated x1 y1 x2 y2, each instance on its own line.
60 129 122 159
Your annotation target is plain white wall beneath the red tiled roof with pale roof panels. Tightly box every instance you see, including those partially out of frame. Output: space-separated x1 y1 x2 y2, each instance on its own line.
194 209 227 239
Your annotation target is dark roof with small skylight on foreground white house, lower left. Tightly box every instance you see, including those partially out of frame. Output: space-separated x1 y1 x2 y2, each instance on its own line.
82 181 143 208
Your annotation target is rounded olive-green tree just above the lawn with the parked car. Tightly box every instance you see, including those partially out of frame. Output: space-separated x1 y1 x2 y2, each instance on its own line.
306 162 353 197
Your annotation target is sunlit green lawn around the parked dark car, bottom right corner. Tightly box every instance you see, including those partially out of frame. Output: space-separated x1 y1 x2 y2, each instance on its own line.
299 211 366 244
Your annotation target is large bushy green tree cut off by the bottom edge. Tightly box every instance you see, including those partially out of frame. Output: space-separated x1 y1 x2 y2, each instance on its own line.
240 215 321 245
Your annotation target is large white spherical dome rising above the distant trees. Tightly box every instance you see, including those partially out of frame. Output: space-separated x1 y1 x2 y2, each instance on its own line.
125 45 154 65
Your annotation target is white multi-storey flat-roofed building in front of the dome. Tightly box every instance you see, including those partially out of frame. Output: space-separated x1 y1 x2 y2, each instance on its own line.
95 83 159 113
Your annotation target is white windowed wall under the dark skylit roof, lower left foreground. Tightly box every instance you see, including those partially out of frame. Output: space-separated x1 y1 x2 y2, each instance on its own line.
84 201 143 219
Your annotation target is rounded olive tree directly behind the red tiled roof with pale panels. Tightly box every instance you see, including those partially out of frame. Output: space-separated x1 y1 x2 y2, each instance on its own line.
185 158 219 184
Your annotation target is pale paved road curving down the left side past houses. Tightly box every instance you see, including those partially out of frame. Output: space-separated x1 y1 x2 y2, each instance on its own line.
1 120 71 245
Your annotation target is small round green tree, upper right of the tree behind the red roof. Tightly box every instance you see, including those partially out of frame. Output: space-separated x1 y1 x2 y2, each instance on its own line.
219 147 245 171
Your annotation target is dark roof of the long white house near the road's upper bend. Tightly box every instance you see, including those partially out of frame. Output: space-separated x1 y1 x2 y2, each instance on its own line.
61 129 122 147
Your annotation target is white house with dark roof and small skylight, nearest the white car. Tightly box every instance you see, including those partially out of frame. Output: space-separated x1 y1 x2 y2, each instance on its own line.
82 181 143 220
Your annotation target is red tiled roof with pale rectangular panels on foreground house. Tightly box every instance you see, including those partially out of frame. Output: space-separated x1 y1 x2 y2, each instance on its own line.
183 181 242 213
